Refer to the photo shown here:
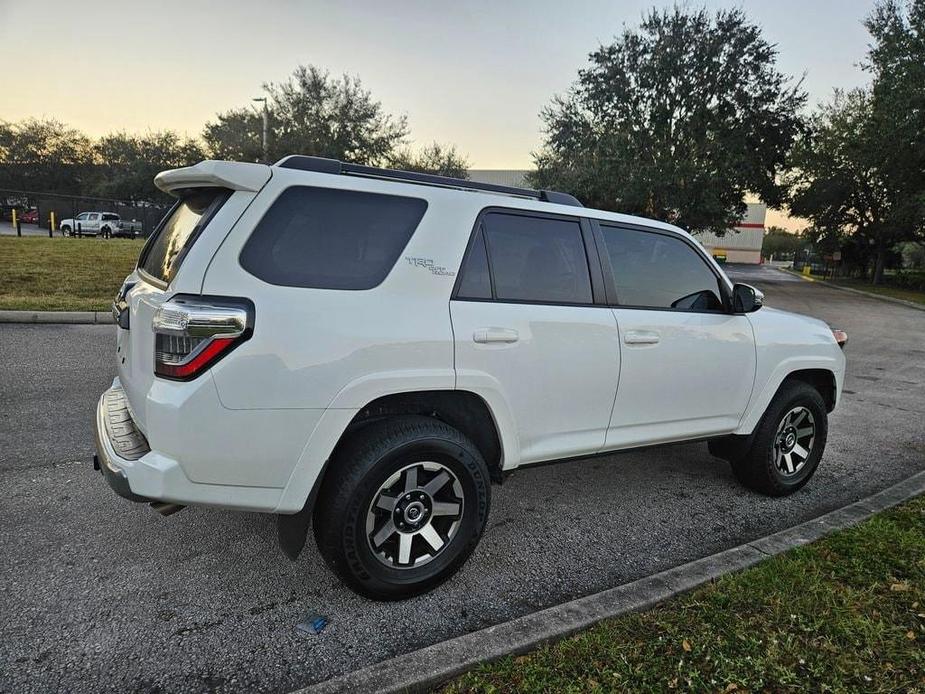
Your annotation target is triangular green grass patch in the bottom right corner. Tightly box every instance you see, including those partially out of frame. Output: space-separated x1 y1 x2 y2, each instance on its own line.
444 497 925 693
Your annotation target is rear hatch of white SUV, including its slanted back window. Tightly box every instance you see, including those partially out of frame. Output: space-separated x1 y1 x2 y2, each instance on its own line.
116 188 232 433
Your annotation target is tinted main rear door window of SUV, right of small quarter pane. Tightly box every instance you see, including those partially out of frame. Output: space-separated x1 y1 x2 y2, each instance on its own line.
482 212 592 304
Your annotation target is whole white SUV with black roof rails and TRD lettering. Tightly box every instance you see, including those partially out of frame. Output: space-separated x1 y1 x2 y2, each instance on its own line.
96 156 845 599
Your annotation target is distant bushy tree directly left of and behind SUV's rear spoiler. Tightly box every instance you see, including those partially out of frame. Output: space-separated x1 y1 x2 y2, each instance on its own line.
87 130 205 201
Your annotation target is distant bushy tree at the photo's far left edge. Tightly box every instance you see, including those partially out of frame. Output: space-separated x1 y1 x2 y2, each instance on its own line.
0 118 94 194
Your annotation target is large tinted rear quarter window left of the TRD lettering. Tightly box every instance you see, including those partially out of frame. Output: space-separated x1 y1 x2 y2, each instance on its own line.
240 186 427 289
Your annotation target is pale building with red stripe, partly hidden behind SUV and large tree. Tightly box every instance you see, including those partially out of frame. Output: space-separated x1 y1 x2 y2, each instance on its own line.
469 169 768 265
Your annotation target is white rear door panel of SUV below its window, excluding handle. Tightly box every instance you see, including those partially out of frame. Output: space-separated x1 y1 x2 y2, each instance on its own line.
450 301 620 469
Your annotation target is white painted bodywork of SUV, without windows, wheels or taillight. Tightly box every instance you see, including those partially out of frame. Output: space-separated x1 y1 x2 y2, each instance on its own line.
99 162 844 513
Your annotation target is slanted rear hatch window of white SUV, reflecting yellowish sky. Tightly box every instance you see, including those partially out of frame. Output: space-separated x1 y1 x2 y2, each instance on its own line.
138 188 230 283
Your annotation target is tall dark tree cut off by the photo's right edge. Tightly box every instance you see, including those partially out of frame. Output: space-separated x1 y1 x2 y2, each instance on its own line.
790 0 925 284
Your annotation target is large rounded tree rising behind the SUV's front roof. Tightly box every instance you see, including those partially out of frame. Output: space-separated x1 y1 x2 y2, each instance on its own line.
532 7 806 234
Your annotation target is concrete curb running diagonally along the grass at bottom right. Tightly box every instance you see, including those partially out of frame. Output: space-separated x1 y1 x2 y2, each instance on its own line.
304 471 925 694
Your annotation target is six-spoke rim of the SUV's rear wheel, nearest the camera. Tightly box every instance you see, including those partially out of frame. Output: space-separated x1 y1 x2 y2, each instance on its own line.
366 461 464 569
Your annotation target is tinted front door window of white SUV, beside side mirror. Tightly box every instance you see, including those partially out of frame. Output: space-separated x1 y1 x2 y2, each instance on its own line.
601 226 723 311
